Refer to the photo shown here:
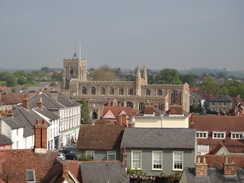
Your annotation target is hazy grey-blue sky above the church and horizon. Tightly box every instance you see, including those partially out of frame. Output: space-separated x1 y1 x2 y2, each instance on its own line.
0 0 244 70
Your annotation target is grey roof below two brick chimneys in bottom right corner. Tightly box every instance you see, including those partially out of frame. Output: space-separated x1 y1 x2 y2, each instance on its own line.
180 168 244 183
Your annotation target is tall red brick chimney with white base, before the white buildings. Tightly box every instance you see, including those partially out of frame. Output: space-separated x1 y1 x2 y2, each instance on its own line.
34 119 47 153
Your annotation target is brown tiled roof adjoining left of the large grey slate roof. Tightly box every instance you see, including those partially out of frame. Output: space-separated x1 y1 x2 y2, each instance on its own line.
76 125 124 149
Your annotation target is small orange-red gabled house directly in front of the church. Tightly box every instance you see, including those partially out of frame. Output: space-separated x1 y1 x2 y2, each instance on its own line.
102 105 135 126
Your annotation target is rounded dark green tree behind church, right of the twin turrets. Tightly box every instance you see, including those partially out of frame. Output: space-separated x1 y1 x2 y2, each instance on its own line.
155 69 182 84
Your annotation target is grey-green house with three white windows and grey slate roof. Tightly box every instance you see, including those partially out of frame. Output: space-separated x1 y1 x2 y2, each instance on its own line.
121 128 196 176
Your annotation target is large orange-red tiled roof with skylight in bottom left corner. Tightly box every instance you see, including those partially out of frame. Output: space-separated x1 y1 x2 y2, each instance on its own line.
0 149 57 182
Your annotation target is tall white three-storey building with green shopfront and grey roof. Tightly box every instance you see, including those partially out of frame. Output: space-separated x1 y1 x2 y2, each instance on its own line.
29 91 81 148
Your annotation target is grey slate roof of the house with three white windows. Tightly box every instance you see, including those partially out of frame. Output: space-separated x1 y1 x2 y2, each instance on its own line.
121 128 196 149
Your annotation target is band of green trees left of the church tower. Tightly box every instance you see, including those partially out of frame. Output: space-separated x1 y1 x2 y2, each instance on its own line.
0 67 62 87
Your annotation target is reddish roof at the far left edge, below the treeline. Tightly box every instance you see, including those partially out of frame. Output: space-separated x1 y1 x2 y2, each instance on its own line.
0 94 24 105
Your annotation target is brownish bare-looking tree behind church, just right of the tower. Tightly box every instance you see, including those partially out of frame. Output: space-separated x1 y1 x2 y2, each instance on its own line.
93 65 118 81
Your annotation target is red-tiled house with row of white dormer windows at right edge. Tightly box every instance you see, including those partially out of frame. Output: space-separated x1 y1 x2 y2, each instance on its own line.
189 114 244 155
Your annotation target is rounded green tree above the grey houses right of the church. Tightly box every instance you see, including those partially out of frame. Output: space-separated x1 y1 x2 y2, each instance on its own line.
201 76 220 96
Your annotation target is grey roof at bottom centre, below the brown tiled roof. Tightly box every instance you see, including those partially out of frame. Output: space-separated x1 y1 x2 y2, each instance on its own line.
80 161 129 183
